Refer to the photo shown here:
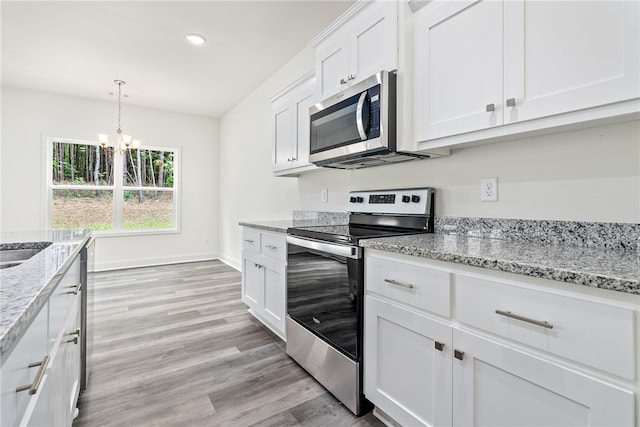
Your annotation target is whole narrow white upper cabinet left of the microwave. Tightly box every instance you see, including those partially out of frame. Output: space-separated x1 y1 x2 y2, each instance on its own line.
271 71 316 176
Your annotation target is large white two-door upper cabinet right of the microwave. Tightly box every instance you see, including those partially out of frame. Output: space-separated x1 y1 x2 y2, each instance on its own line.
414 0 640 142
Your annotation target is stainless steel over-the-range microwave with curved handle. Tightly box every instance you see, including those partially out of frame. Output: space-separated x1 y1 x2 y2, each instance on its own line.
309 71 429 169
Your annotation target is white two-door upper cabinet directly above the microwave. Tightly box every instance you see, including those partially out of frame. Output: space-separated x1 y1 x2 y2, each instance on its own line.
312 1 398 100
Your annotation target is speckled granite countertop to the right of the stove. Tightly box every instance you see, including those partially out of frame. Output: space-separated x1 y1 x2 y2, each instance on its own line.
360 233 640 295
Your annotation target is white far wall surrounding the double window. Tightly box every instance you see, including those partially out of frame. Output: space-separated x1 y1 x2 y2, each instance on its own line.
0 87 219 269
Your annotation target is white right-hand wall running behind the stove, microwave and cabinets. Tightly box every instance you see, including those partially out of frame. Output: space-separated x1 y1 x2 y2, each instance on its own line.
220 50 640 265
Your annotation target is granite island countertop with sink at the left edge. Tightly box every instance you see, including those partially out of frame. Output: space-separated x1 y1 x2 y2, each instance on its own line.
0 230 91 362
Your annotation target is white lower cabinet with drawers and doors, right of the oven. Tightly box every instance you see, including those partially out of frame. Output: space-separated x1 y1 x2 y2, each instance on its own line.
364 249 640 427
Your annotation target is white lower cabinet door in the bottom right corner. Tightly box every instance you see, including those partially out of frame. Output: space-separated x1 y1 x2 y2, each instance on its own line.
453 330 634 426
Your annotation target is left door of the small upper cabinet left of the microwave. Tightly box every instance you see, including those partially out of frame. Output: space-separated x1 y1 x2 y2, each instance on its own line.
273 98 296 170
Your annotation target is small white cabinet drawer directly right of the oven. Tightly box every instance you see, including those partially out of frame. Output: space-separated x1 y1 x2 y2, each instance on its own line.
365 255 452 317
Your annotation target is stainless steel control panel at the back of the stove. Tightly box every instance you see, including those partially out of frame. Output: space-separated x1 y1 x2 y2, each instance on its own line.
347 187 435 215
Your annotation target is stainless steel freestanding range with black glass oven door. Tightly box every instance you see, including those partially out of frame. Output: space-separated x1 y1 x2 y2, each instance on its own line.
286 188 435 415
